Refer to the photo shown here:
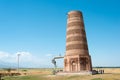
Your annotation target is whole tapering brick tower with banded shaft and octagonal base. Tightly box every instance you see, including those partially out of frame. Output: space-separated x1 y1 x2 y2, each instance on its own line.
64 11 92 72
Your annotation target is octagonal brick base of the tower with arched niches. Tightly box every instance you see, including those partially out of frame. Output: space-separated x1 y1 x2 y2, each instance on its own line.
64 55 92 73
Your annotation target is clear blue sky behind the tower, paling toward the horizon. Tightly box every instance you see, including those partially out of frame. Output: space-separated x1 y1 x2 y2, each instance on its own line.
0 0 120 67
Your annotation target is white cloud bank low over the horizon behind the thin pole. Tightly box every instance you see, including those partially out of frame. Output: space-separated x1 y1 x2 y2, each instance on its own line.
0 51 52 67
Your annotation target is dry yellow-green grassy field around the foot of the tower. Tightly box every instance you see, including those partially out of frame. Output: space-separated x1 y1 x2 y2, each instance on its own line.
4 68 120 80
